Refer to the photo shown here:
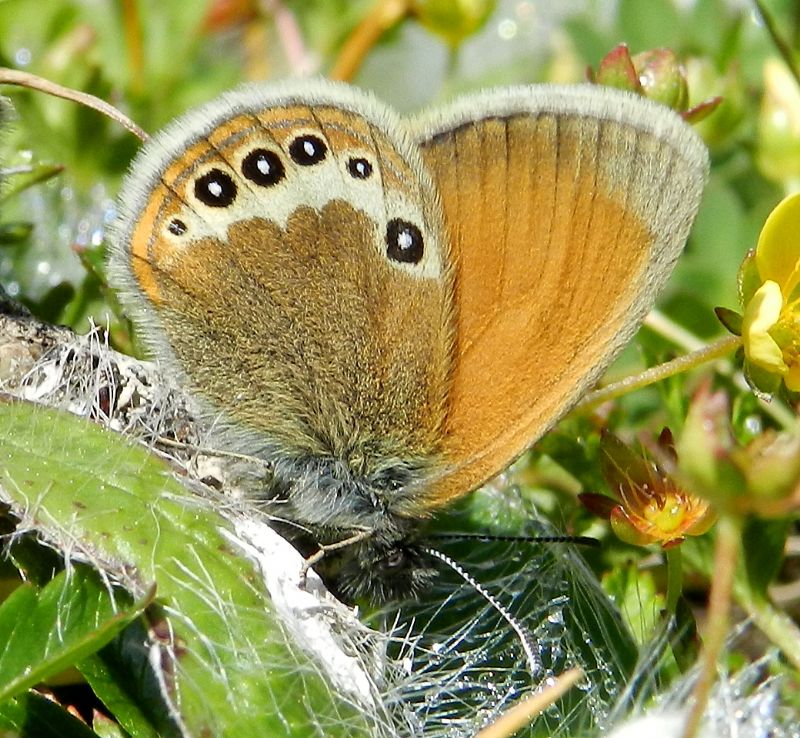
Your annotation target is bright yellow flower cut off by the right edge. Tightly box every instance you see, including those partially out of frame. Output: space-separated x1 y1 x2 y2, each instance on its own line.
739 194 800 392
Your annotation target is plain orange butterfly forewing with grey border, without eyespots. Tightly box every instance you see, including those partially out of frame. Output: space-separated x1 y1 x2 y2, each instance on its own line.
412 86 708 507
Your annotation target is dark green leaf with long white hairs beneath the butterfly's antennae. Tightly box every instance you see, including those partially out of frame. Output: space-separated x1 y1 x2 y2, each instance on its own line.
396 486 639 738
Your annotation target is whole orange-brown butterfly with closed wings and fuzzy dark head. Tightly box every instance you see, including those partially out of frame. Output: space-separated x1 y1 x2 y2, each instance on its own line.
110 82 706 599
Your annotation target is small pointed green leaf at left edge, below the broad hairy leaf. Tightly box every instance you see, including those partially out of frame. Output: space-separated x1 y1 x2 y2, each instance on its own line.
0 566 150 702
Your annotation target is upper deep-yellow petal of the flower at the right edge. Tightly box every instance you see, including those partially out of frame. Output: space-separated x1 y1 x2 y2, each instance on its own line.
756 193 800 298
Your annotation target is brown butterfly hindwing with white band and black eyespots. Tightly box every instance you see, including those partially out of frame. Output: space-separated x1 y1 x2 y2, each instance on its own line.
111 81 451 466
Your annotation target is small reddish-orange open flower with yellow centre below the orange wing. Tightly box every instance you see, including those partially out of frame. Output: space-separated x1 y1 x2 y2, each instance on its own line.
580 430 716 548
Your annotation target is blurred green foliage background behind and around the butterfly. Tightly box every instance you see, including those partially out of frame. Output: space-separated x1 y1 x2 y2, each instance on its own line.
0 0 800 732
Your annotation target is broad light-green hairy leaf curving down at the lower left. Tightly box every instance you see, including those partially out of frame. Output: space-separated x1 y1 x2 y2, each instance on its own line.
0 403 368 738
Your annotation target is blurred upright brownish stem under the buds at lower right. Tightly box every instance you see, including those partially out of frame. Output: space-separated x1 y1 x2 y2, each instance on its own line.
682 514 742 738
